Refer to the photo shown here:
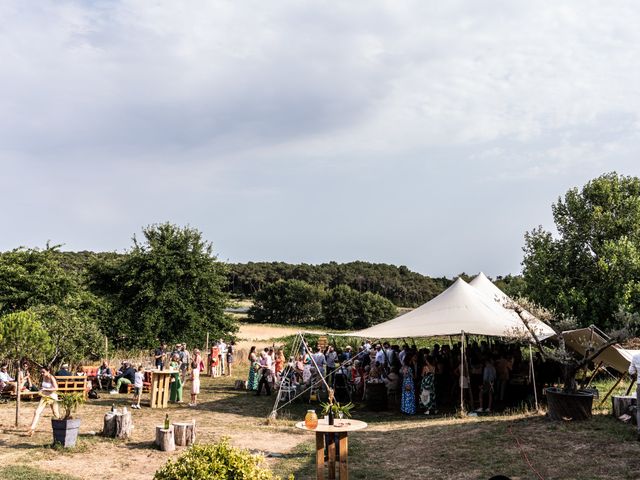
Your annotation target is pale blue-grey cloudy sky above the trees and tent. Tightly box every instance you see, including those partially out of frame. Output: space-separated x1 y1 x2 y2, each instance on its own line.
0 0 640 277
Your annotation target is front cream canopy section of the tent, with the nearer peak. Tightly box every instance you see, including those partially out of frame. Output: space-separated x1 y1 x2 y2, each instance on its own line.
346 278 544 339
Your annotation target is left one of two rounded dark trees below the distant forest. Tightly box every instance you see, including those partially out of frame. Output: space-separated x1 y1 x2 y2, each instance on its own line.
249 280 324 325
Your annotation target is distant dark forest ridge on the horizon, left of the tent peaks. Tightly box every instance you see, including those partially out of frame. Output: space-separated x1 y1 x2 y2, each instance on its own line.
227 261 453 307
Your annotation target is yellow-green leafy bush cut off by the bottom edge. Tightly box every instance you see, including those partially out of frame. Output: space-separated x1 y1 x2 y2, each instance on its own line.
153 438 288 480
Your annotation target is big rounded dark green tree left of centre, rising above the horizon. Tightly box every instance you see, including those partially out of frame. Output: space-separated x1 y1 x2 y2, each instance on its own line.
90 223 237 347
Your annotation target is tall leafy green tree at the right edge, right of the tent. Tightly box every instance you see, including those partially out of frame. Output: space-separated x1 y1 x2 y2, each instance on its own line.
523 173 640 328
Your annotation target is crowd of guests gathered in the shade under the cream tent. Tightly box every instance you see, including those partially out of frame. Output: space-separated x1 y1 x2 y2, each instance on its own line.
247 341 529 415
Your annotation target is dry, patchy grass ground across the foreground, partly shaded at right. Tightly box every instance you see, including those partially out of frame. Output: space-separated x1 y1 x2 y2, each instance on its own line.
0 324 640 480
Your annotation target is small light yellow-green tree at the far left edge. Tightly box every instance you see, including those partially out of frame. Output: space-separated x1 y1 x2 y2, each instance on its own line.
0 310 52 361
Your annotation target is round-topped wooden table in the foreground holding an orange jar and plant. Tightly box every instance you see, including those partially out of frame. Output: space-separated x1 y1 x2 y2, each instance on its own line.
296 419 367 480
